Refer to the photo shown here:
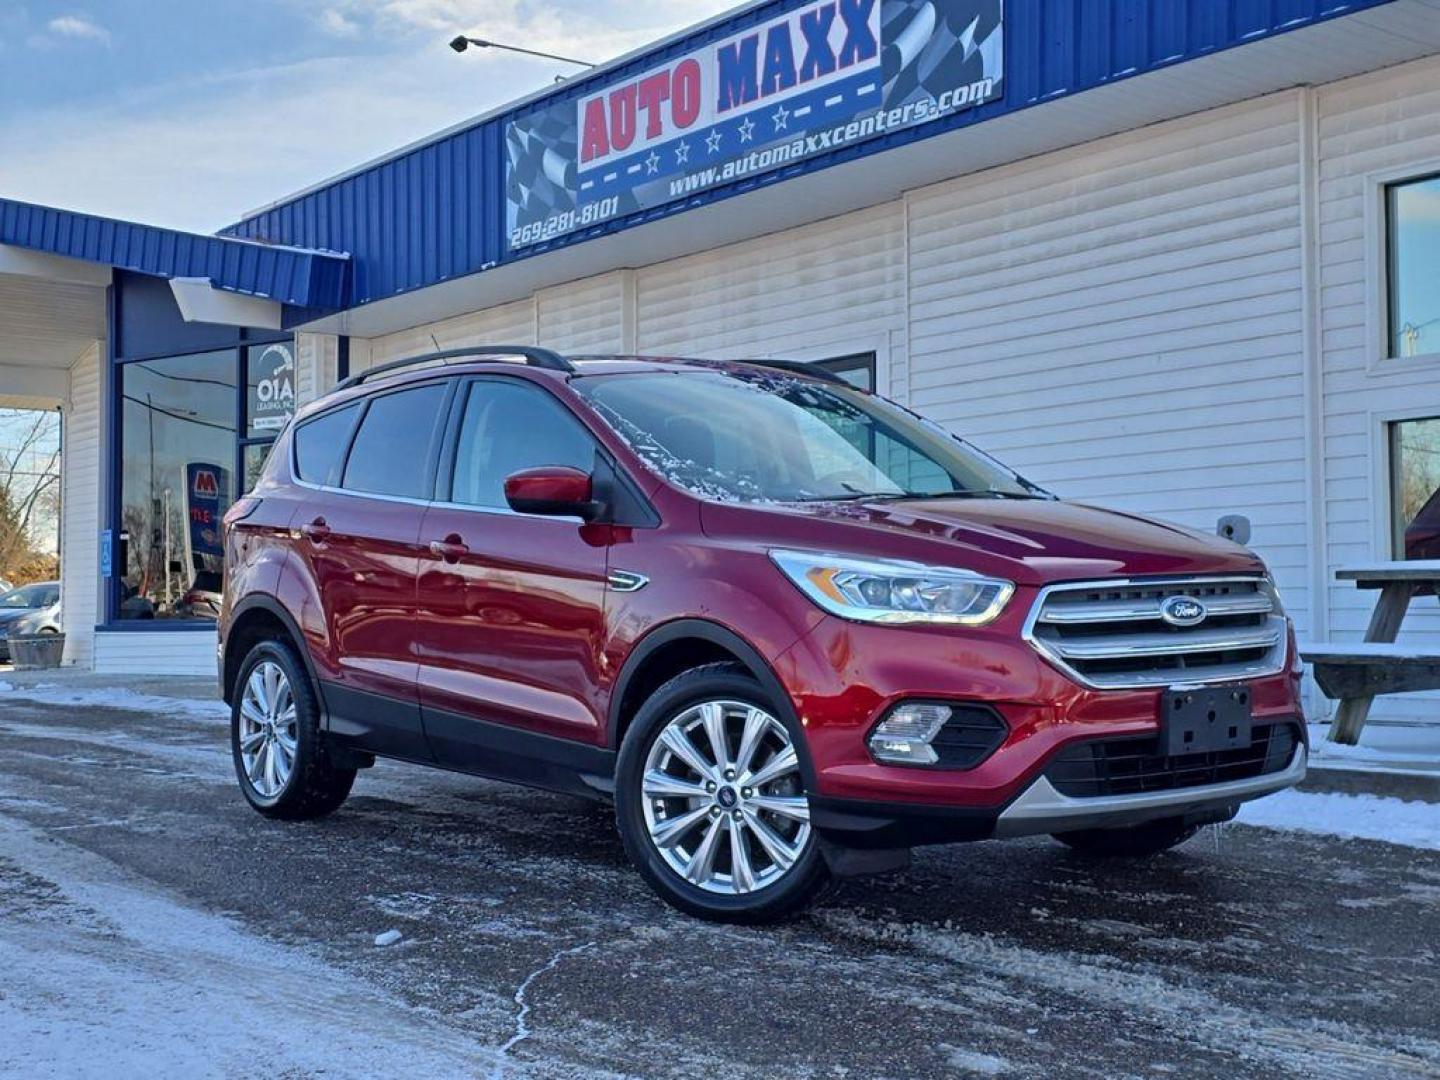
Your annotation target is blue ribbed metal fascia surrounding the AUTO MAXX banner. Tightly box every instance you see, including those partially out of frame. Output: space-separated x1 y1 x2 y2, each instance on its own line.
223 0 1394 307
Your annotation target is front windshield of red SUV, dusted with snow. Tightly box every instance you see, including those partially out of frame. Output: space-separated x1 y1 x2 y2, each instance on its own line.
573 372 1047 503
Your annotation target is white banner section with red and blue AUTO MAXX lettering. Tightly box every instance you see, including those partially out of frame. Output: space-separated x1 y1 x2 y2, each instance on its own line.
576 0 880 171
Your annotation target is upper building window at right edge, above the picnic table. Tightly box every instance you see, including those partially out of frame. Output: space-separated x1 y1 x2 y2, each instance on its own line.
1385 176 1440 357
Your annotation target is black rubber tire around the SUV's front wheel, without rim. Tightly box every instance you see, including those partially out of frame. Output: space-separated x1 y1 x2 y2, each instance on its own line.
615 664 831 924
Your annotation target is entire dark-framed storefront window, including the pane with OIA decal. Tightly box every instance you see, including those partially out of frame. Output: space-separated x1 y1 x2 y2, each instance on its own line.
112 340 295 622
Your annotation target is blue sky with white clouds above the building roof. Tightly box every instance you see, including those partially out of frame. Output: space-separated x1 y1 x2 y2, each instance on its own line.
0 0 737 232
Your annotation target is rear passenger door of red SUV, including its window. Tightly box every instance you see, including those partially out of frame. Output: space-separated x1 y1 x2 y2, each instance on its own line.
292 380 451 757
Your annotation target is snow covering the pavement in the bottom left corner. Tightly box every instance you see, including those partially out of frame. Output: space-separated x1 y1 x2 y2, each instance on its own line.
0 822 524 1079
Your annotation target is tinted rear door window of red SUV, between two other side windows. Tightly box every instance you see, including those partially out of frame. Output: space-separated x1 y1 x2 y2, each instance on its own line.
344 383 445 498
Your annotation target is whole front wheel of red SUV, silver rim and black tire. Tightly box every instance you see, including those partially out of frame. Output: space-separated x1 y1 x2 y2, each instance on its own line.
615 664 829 923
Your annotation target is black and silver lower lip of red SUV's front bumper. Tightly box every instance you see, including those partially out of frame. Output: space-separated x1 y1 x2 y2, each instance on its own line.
811 743 1308 850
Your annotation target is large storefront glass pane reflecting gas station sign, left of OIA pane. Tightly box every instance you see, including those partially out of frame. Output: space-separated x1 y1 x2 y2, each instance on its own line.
117 350 239 619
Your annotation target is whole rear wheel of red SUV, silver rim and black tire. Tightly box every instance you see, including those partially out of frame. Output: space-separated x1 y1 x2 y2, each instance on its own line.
230 641 356 821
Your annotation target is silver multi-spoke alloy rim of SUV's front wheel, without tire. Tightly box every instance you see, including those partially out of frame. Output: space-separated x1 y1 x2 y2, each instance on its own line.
641 700 811 896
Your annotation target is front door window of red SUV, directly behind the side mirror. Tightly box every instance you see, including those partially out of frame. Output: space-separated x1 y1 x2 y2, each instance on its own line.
451 382 595 508
